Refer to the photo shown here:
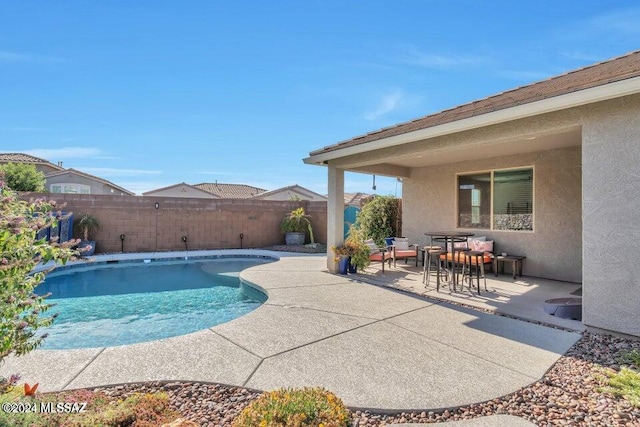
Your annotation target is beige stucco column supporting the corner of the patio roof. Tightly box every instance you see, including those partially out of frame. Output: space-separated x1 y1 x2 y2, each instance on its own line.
327 164 344 273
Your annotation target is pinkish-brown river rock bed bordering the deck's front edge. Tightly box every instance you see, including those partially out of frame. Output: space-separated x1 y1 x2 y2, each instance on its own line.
92 333 640 427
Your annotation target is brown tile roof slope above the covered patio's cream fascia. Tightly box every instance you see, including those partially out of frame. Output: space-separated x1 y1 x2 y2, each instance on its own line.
310 51 640 156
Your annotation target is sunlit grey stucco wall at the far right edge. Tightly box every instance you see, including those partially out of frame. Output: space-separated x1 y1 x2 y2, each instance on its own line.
582 95 640 336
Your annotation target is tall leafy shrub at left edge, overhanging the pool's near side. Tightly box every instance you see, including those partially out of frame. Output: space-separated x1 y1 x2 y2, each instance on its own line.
0 172 78 372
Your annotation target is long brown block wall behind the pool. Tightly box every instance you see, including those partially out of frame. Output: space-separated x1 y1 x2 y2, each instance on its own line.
22 193 327 253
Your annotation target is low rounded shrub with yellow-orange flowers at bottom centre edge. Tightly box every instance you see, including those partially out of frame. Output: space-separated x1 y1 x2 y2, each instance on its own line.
232 388 349 427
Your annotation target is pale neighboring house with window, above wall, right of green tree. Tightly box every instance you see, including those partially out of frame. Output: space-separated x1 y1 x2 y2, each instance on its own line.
45 169 135 196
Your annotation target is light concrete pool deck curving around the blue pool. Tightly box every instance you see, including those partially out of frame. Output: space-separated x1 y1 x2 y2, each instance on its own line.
0 254 581 412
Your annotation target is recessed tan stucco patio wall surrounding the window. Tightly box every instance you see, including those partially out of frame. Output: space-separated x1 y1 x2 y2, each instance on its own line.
402 146 582 282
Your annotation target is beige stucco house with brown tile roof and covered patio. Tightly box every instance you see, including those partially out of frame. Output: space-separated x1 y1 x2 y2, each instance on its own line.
304 51 640 336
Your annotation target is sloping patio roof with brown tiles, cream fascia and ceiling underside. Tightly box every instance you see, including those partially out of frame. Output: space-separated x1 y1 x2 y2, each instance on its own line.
304 51 640 177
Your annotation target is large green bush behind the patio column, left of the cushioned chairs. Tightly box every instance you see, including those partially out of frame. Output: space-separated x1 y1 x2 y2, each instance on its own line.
356 196 400 246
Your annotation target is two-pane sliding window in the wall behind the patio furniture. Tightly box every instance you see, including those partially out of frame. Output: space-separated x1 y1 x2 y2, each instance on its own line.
458 168 533 231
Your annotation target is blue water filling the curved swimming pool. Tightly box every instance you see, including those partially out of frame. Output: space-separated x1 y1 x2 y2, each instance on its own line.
36 258 270 349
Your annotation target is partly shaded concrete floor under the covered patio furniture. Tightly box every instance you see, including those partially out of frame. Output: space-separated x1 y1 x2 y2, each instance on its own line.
354 263 586 331
